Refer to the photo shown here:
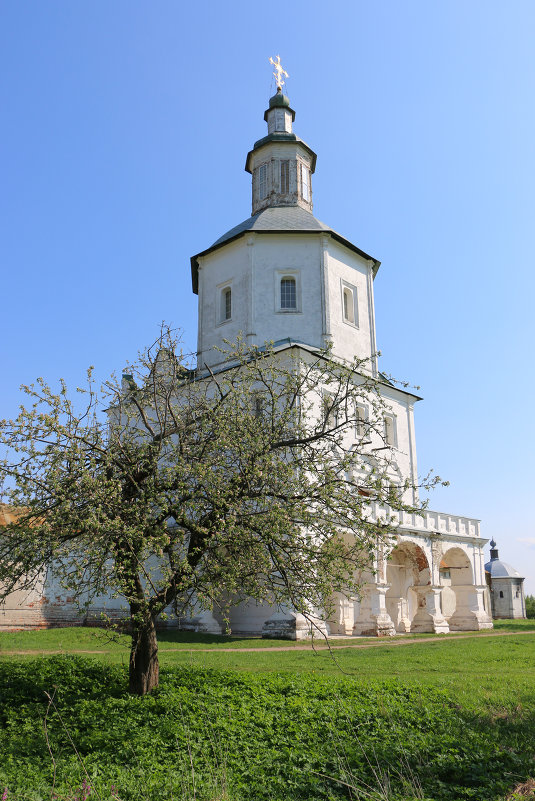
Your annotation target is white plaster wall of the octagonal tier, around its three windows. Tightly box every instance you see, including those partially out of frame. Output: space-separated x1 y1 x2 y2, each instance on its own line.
198 233 386 371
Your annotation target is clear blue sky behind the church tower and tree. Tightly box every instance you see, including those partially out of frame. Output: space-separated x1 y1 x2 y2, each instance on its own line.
0 0 535 593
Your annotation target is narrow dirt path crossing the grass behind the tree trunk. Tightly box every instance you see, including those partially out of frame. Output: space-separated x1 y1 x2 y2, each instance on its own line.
0 630 535 656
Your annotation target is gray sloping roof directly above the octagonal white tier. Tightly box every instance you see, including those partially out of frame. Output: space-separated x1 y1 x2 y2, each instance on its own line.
191 206 381 293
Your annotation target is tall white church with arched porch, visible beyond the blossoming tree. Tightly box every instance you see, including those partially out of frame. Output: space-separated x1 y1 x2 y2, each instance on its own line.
0 57 492 639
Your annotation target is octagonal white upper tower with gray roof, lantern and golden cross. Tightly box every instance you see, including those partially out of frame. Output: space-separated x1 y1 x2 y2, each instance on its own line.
191 57 380 375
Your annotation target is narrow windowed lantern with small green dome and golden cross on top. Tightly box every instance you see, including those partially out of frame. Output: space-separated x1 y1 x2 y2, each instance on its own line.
245 57 316 215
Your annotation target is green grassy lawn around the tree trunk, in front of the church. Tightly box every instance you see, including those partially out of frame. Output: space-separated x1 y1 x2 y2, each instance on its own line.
0 621 535 801
